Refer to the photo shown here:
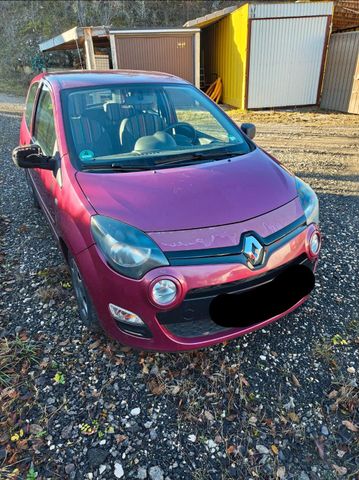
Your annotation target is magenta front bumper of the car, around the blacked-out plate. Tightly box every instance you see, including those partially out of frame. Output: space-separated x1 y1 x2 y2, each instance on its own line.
77 219 317 351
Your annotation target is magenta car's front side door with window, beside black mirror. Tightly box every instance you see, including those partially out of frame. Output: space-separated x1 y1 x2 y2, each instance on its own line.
31 84 60 230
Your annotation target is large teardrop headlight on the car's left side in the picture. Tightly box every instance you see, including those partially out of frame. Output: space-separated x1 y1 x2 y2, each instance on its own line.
91 215 169 280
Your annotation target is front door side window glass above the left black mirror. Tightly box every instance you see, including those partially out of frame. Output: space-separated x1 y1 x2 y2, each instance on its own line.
34 87 56 155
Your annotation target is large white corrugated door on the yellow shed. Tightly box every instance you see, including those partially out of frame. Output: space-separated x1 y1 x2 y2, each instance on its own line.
247 17 327 108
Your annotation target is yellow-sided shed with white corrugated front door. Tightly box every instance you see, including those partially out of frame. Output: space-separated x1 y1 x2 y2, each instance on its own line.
184 2 333 109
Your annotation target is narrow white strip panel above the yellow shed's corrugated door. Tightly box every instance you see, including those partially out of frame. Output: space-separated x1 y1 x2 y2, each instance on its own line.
249 2 333 18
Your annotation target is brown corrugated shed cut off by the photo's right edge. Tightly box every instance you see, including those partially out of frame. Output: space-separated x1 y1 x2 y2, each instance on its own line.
320 31 359 114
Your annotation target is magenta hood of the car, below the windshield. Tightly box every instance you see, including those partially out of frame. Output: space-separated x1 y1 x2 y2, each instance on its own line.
76 148 297 232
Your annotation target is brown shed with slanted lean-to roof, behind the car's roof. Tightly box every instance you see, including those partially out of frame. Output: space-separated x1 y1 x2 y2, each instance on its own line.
39 26 200 87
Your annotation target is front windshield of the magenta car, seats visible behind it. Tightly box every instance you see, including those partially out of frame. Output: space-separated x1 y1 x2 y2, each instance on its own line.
61 84 253 171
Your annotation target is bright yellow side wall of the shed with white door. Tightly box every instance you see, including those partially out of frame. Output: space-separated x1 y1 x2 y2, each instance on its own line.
201 3 249 109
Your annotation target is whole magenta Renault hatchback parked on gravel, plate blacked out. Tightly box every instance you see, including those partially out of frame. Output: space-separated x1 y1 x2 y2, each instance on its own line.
13 71 321 351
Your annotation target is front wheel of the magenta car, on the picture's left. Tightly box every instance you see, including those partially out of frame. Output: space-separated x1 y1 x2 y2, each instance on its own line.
68 253 102 332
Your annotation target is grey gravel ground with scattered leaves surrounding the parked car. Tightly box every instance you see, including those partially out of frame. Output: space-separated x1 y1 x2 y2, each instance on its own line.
0 98 359 480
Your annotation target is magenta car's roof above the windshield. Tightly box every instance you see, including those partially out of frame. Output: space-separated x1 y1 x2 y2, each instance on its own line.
32 70 189 90
